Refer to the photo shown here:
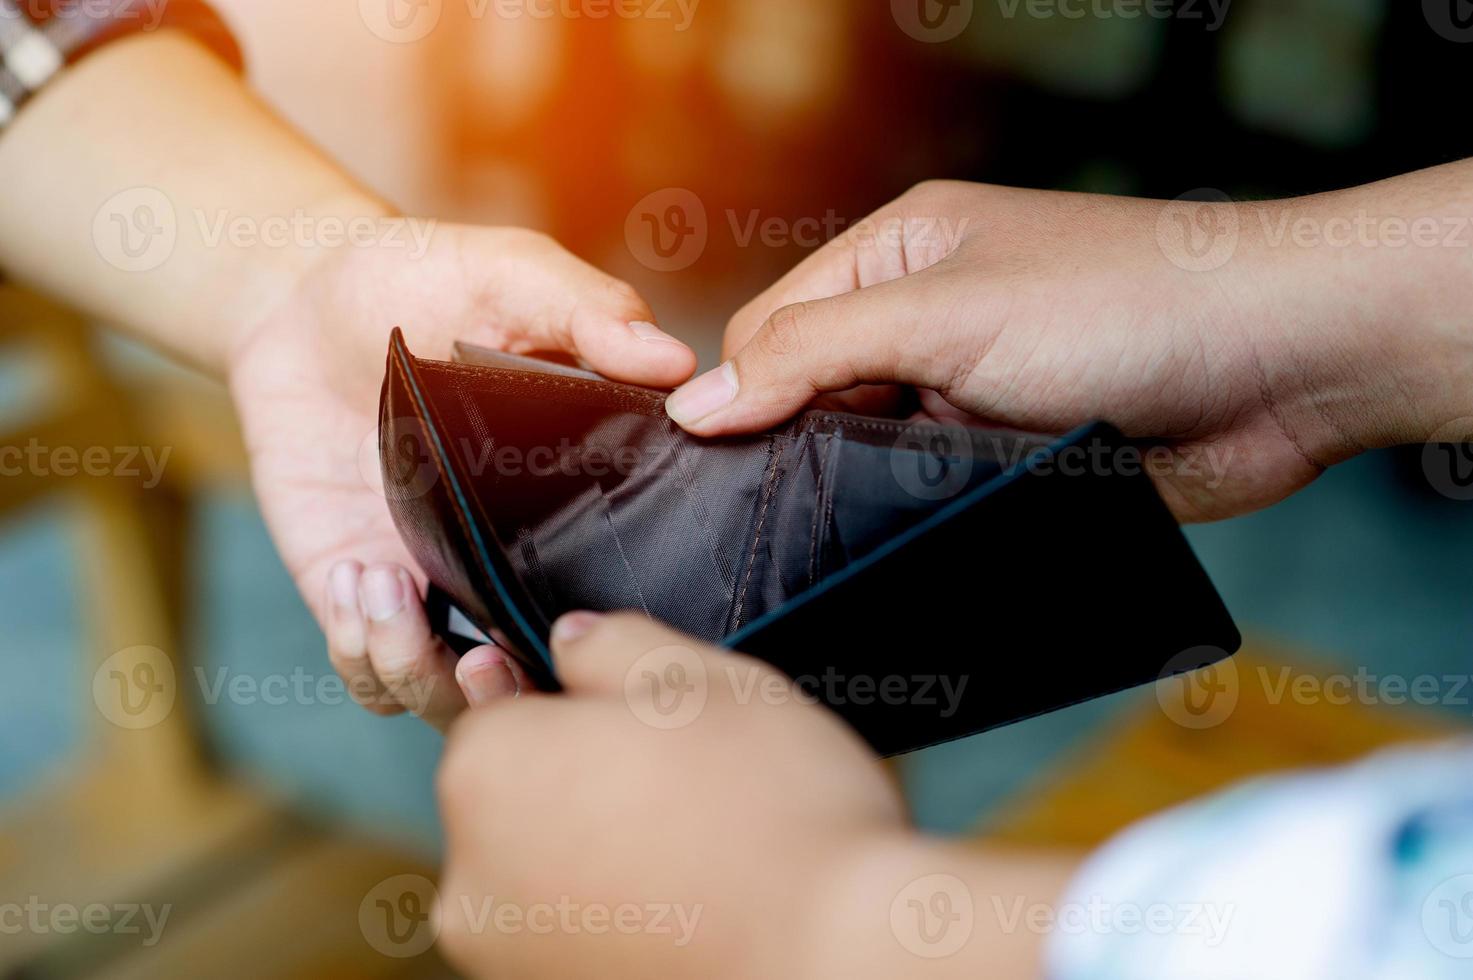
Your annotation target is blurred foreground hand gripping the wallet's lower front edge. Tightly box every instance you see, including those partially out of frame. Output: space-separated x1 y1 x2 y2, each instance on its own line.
439 613 907 977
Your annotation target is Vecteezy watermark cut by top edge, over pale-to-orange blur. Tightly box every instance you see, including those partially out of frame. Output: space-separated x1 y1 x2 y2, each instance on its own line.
358 0 701 44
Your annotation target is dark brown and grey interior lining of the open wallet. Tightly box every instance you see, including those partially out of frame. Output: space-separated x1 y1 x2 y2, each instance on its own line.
418 361 1042 641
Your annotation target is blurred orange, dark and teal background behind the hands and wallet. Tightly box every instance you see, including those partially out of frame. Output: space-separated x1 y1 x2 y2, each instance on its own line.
0 0 1473 976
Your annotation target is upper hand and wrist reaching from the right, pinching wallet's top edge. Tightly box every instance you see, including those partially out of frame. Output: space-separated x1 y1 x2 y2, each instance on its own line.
669 179 1473 520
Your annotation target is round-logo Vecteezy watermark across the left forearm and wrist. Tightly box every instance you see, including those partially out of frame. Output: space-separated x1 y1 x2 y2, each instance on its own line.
93 187 437 273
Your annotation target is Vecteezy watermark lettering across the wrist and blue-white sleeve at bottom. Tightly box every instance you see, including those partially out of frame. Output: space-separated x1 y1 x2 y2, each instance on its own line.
991 895 1237 949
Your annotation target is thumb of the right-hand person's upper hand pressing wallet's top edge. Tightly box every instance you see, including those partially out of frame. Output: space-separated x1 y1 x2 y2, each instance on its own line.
666 273 949 436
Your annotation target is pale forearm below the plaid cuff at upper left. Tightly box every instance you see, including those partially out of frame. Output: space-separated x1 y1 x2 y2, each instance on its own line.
0 31 387 373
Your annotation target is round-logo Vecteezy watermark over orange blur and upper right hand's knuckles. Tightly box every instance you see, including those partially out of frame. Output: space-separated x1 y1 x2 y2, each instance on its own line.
625 187 971 273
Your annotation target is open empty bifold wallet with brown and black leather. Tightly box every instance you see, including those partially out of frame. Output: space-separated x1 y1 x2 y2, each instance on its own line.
379 329 1240 755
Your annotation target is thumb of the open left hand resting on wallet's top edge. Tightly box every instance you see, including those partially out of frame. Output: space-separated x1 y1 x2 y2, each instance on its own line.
493 236 695 388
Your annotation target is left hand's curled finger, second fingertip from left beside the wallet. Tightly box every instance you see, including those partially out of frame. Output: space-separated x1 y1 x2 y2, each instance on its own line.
358 563 465 731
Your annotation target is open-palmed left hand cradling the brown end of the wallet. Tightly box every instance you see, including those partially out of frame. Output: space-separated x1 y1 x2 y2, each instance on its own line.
230 225 695 729
